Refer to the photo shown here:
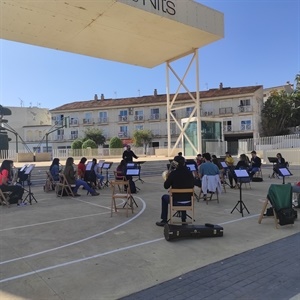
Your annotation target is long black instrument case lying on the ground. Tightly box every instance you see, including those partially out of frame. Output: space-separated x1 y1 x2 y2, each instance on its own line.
164 223 223 241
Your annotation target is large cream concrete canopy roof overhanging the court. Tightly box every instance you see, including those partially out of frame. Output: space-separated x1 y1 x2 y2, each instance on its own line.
0 0 224 68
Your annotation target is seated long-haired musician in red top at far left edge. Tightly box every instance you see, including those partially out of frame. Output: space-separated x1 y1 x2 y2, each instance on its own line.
0 160 26 206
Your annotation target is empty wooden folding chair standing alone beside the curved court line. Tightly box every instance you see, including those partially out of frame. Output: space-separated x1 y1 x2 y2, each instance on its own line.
110 180 135 217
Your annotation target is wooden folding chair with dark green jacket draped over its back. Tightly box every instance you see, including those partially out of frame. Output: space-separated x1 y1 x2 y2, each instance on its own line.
258 183 292 228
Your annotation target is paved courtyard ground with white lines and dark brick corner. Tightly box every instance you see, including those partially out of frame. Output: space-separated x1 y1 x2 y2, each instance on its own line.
0 161 300 300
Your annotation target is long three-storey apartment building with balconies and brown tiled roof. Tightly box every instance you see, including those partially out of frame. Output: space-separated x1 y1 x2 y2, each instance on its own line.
49 83 264 153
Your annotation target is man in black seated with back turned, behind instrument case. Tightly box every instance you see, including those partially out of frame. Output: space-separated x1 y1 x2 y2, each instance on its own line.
156 156 194 226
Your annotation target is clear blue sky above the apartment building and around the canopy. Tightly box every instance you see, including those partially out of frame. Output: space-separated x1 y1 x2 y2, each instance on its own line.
0 0 300 109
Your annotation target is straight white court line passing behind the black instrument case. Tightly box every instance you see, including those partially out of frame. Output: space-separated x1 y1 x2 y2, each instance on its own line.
0 211 258 283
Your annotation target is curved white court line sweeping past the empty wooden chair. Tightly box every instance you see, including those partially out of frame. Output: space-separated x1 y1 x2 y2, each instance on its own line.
0 197 146 265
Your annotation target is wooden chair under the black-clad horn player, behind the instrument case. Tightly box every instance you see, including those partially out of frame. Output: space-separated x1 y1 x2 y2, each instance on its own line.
169 188 195 224
